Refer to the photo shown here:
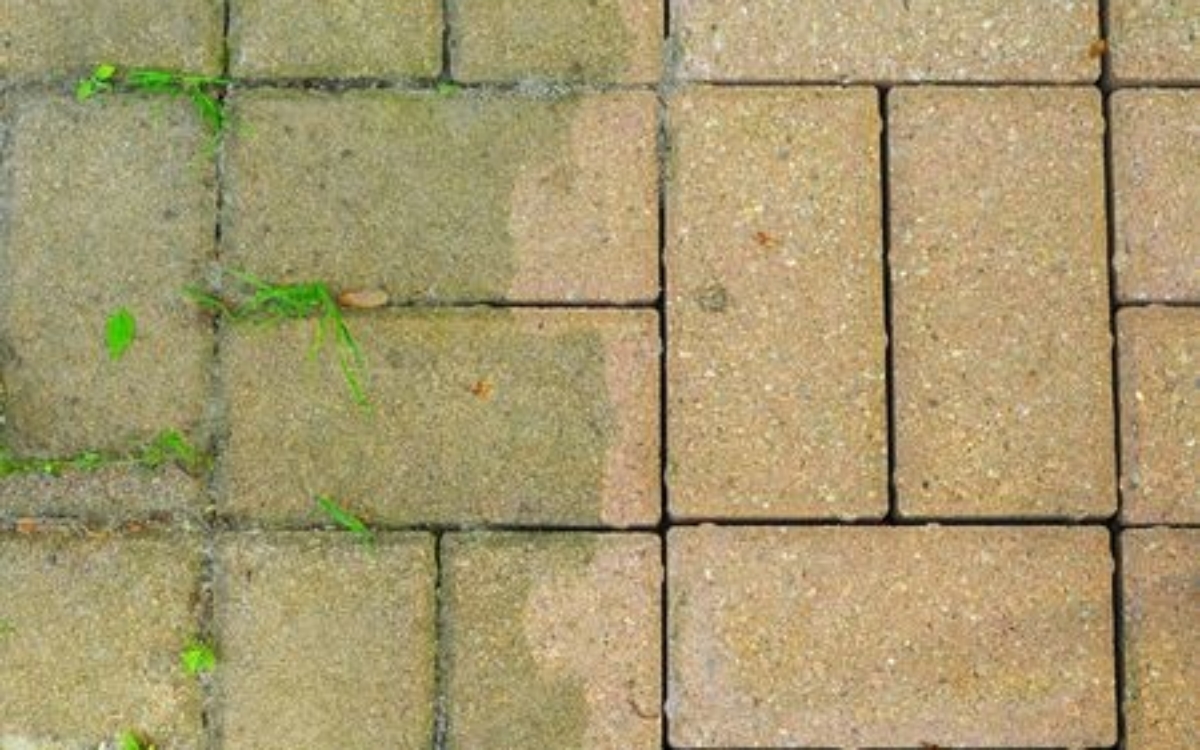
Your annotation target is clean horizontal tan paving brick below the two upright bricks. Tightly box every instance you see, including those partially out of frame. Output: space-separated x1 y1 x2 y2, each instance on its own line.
667 527 1116 748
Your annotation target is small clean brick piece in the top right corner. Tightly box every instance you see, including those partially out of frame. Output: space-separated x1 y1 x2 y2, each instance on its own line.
1108 0 1200 84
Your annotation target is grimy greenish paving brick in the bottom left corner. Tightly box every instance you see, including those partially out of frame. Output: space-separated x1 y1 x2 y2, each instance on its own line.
0 534 203 750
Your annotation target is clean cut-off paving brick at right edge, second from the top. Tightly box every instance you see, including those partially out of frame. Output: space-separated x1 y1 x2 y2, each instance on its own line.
1111 90 1200 302
